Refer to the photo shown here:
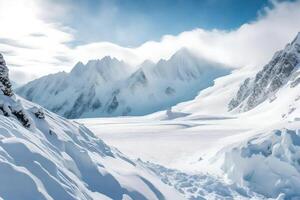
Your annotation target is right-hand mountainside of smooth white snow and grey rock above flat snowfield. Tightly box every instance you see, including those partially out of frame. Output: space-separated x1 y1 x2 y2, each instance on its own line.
173 34 300 120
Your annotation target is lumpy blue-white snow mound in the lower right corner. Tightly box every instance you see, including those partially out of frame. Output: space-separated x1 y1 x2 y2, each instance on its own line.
217 127 300 199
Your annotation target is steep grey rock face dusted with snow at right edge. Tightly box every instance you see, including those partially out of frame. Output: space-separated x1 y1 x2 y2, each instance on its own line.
228 33 300 111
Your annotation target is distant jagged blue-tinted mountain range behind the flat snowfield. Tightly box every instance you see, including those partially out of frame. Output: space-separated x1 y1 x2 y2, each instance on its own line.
17 49 230 118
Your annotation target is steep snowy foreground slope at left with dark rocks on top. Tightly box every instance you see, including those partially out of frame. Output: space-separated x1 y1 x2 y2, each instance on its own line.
0 54 183 200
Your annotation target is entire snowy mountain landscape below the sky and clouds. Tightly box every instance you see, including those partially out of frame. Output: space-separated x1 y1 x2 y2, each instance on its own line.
0 31 300 200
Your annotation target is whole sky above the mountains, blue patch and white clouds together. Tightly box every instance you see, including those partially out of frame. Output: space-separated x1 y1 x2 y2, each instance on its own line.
0 0 300 83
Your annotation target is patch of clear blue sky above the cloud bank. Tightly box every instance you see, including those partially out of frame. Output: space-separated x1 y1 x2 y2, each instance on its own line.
47 0 270 46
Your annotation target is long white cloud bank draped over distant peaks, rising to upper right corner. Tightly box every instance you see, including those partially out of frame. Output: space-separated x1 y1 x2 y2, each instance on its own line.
77 1 300 67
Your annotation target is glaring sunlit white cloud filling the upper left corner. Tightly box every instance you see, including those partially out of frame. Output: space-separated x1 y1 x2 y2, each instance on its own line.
0 0 73 82
